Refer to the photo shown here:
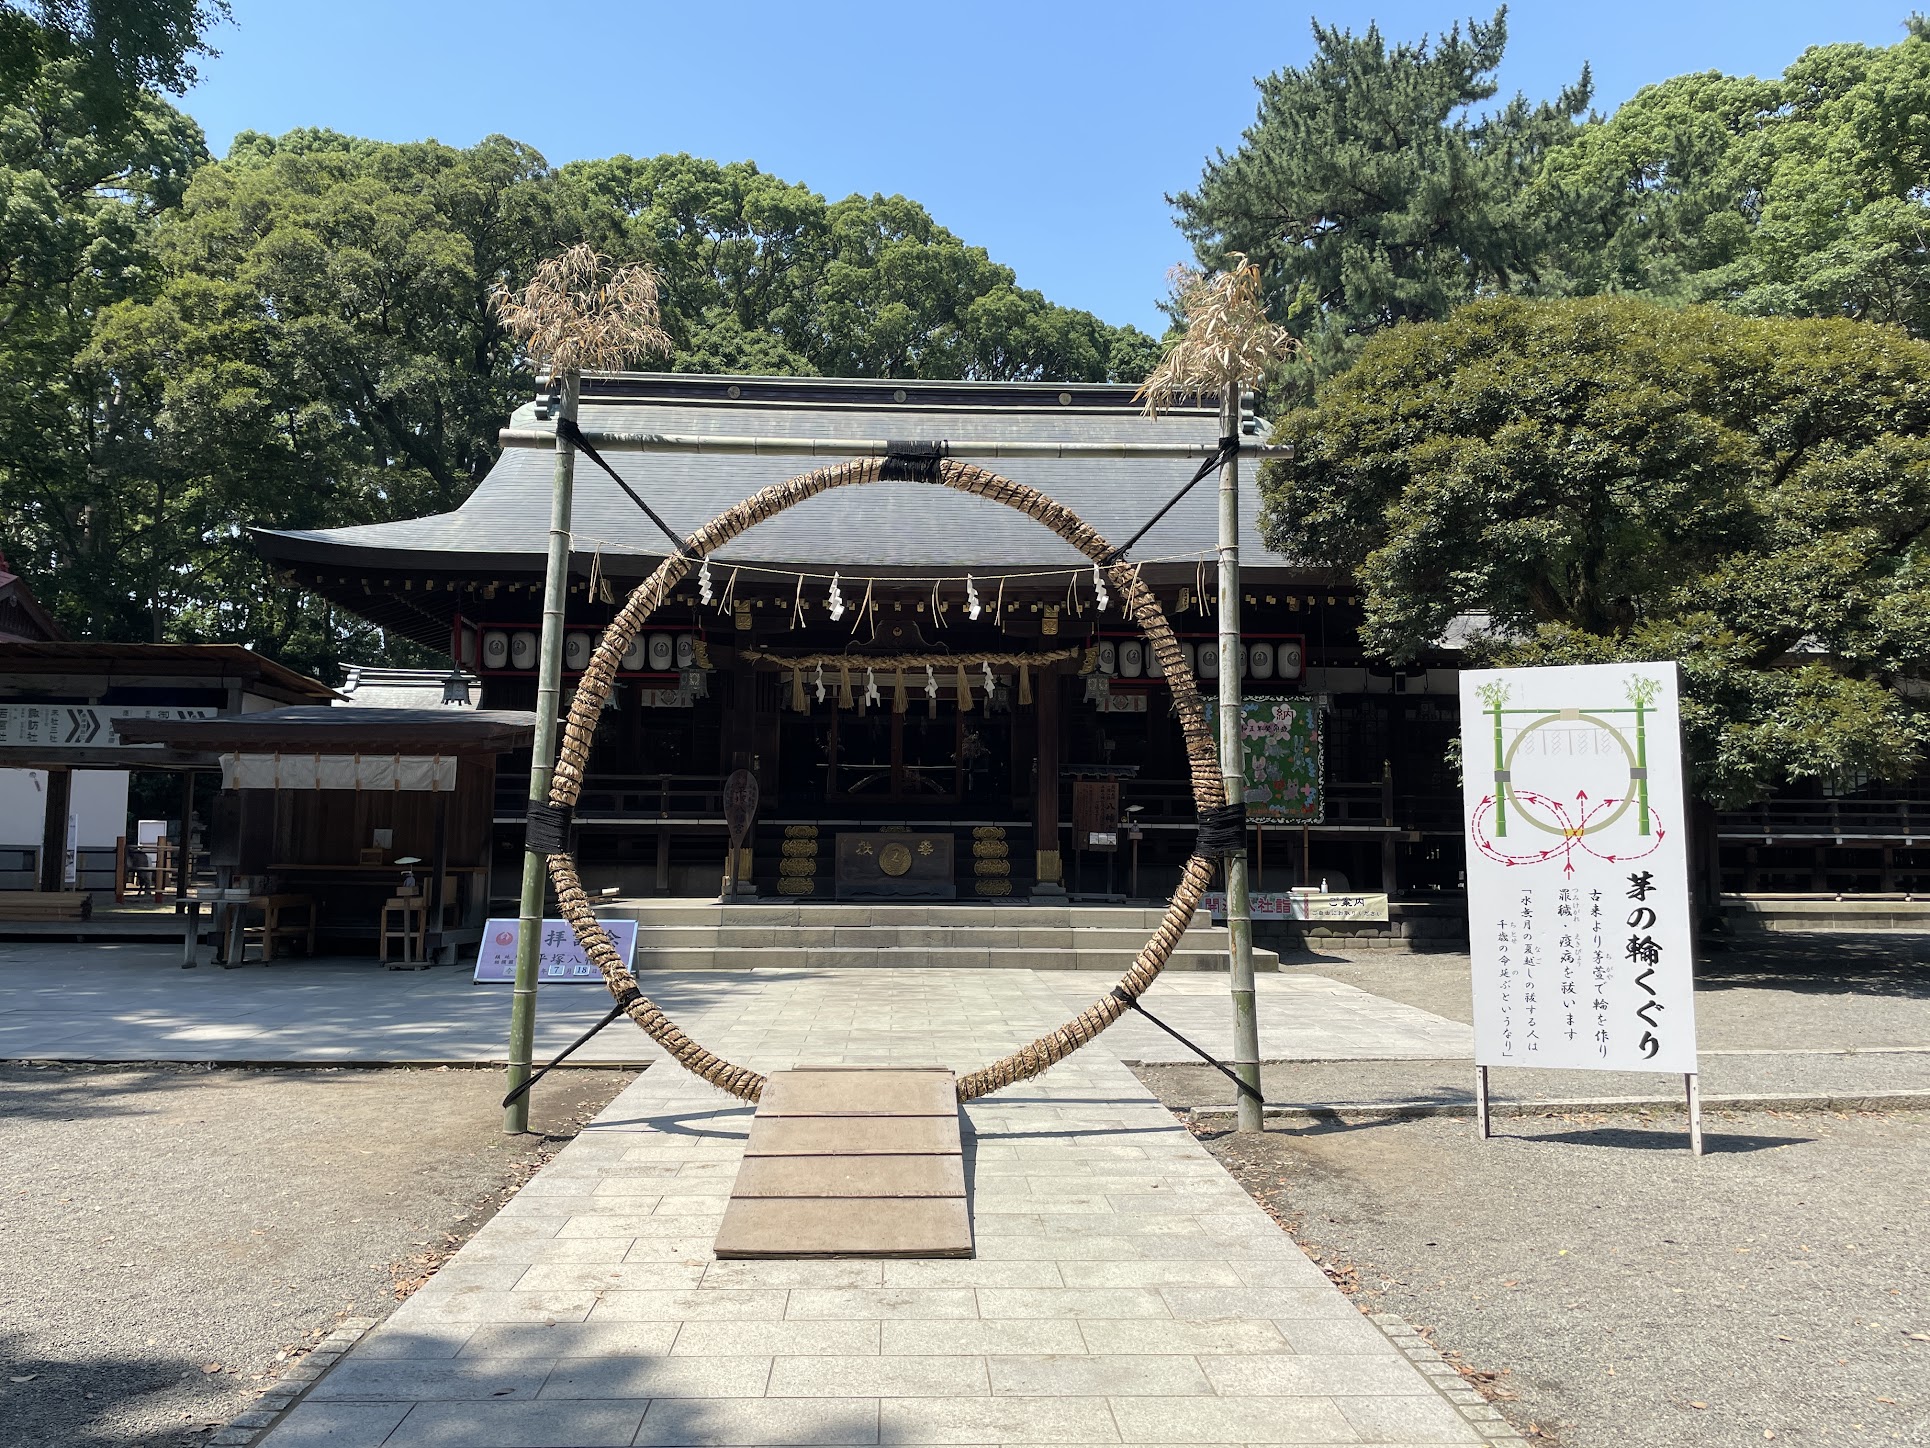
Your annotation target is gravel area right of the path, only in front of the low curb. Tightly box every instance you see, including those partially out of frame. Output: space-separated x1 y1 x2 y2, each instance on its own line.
1158 1112 1930 1448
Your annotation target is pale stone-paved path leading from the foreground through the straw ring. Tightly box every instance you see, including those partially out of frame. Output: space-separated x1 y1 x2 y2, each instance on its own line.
266 971 1492 1448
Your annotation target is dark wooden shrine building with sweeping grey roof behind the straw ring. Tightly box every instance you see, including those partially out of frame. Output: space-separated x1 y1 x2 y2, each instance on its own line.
255 373 1930 913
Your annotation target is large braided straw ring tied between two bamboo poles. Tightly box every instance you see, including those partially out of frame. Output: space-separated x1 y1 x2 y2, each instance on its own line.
548 458 1226 1100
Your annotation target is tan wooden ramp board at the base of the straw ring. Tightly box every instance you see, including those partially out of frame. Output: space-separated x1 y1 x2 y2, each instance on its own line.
716 1066 973 1257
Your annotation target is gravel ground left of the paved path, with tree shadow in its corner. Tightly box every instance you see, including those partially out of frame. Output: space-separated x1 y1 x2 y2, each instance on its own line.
0 1066 635 1448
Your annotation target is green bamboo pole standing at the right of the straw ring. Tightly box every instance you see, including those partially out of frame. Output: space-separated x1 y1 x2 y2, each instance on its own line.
1218 384 1266 1131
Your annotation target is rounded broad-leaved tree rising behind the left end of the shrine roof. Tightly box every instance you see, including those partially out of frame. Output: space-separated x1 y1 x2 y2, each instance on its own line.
89 131 558 666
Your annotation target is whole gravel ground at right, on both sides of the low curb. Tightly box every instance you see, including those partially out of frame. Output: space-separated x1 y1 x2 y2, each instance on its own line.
1139 934 1930 1448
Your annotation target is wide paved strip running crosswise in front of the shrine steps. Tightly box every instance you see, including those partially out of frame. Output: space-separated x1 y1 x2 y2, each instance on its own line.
0 942 1473 1064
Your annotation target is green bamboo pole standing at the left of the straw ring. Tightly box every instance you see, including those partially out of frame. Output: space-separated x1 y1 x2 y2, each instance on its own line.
502 369 581 1135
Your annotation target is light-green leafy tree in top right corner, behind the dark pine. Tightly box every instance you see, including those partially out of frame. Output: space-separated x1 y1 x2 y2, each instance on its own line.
1529 23 1930 336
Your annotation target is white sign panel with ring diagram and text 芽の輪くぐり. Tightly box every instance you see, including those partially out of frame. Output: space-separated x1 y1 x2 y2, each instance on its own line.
1461 664 1696 1073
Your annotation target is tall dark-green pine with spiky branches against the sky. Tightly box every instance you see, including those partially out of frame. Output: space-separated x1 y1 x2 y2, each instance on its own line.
1172 8 1590 396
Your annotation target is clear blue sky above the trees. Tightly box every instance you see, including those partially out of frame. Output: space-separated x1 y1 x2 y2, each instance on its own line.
183 0 1911 332
